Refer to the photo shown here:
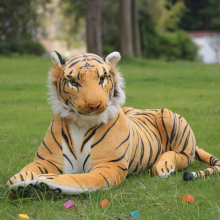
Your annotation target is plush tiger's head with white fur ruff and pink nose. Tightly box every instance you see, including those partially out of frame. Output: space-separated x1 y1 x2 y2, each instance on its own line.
49 51 125 126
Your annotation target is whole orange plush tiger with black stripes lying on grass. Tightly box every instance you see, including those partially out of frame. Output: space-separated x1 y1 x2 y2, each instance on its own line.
7 51 220 194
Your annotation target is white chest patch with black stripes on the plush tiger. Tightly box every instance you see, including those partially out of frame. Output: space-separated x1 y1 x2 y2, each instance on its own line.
62 124 94 174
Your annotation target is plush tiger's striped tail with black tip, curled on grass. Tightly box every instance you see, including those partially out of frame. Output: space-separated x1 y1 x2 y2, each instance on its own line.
183 147 220 181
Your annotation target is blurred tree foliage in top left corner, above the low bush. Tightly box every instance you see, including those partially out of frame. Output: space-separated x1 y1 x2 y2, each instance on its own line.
0 0 51 40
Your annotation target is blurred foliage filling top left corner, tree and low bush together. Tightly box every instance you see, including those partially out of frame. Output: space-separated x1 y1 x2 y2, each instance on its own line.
0 0 51 56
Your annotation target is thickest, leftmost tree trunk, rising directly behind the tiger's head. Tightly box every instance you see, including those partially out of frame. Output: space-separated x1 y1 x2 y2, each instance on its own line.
86 0 102 56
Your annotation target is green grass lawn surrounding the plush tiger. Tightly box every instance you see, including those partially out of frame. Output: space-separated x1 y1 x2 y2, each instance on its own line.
0 57 220 220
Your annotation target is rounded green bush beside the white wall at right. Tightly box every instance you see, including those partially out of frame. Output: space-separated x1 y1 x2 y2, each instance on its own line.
141 29 198 61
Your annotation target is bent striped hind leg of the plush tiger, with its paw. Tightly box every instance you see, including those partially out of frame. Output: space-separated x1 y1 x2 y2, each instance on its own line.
152 109 196 177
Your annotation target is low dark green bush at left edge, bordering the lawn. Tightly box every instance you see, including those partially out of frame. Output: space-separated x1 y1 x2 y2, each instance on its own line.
0 36 45 56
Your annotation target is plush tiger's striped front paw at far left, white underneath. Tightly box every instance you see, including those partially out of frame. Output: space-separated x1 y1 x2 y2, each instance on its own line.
6 171 38 189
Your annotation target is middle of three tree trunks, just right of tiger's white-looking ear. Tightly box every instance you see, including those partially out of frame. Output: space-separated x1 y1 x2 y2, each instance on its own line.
120 0 133 57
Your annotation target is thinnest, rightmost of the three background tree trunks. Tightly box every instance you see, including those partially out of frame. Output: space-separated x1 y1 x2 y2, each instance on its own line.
131 0 142 58
